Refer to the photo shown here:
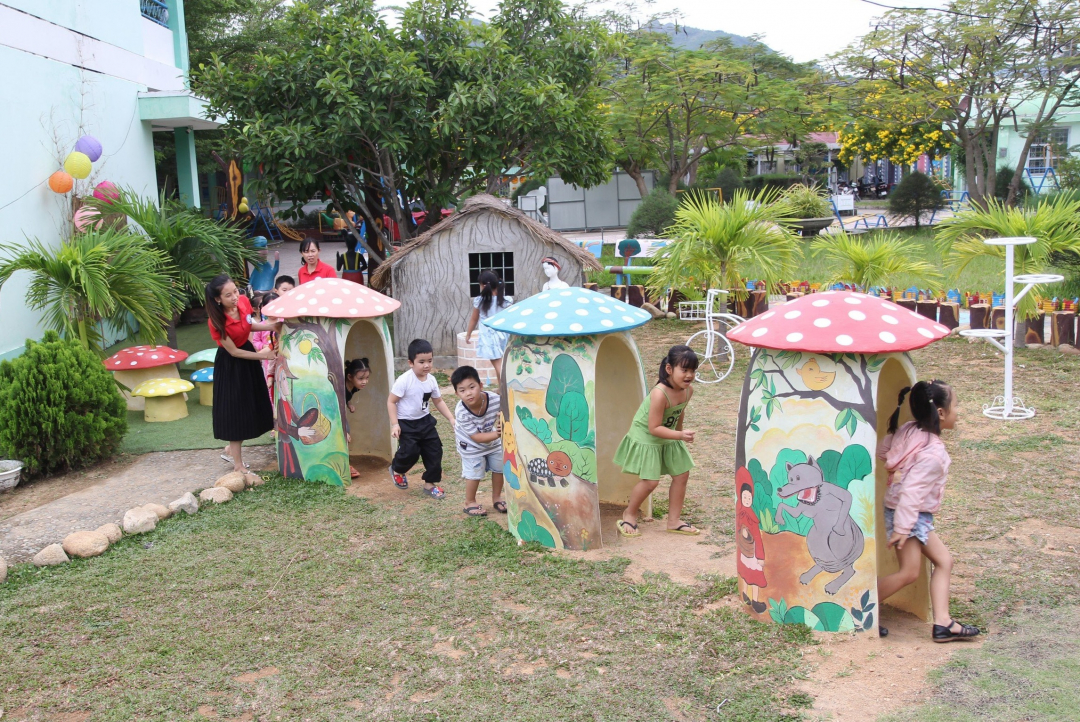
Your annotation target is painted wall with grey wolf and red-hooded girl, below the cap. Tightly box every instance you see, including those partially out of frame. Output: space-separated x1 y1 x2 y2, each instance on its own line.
735 349 924 635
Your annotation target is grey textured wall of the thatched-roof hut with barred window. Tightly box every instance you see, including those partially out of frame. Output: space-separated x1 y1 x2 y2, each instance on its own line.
393 212 581 368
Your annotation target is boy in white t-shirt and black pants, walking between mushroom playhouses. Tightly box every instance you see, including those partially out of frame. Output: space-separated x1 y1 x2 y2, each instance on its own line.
387 339 454 499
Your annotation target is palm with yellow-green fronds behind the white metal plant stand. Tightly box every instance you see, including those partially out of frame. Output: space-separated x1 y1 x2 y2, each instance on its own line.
937 195 1080 322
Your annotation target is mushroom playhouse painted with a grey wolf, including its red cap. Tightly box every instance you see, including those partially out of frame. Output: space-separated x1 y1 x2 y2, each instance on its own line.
728 291 949 636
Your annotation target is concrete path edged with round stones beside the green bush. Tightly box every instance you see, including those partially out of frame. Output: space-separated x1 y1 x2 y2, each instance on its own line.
0 446 276 563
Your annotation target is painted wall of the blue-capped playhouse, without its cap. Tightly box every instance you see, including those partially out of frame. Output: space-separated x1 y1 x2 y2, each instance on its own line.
502 333 645 549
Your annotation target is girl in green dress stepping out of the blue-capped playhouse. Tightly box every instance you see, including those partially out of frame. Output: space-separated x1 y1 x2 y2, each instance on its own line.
615 345 700 536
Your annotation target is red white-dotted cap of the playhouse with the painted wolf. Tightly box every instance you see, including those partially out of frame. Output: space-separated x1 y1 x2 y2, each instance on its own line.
728 290 949 354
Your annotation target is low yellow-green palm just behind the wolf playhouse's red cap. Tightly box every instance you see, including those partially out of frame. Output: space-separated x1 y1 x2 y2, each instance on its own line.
810 232 941 290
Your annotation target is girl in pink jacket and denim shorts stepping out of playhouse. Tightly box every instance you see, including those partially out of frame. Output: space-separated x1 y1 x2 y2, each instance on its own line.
877 381 978 642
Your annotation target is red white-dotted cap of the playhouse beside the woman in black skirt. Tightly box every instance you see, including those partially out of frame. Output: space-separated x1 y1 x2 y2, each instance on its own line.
262 278 401 318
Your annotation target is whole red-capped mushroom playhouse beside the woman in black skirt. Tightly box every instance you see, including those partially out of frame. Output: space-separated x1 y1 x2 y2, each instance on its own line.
262 278 401 486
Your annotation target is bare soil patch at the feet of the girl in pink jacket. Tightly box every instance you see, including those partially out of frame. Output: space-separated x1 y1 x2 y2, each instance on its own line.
798 605 982 720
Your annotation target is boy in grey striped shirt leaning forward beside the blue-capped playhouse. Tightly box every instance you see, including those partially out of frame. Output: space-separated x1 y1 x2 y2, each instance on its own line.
450 366 507 517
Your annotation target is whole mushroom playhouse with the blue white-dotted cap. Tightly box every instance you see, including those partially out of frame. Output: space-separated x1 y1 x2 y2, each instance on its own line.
484 288 651 549
